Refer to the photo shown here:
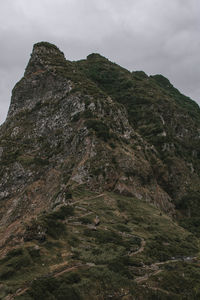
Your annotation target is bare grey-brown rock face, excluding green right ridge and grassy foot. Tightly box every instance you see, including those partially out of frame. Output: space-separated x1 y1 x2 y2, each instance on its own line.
0 43 199 251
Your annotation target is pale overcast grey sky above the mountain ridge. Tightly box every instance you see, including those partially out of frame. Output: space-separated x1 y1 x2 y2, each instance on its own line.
0 0 200 124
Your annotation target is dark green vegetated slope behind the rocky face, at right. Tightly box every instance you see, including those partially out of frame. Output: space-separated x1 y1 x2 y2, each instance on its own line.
79 54 200 202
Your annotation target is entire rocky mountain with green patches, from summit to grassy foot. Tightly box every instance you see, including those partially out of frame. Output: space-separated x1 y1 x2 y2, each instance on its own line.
0 42 200 300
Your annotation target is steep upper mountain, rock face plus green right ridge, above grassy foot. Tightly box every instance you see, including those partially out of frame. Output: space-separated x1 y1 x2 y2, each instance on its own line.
0 42 200 298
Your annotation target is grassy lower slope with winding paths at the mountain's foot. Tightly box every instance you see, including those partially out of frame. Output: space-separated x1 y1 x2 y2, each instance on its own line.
0 187 200 299
